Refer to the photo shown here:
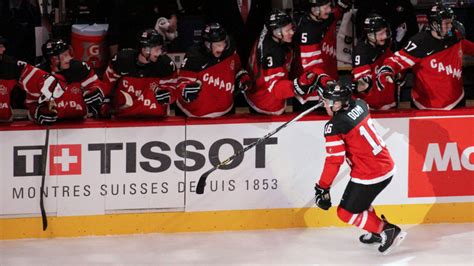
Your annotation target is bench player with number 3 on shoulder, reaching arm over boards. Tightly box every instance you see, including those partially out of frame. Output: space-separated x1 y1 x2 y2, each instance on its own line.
244 10 330 115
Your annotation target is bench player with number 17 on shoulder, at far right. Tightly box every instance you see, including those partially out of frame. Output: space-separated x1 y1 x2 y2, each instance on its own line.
377 4 474 110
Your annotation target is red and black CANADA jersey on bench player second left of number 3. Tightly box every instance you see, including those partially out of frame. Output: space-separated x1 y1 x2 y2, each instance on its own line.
104 49 177 117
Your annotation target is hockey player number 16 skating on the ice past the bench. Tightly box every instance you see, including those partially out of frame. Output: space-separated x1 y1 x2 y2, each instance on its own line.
315 83 406 254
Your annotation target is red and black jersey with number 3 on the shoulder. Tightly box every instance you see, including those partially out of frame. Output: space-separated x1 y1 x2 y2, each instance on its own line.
245 34 295 115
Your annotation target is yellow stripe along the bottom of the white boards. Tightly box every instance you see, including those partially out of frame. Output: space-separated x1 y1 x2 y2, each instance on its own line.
0 202 474 240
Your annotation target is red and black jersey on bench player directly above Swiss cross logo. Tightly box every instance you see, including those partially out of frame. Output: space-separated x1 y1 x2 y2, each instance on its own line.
38 59 104 119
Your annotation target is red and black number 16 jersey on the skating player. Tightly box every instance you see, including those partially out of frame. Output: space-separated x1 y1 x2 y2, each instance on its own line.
319 99 395 188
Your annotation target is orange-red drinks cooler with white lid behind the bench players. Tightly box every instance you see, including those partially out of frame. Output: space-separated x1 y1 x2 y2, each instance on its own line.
71 24 109 69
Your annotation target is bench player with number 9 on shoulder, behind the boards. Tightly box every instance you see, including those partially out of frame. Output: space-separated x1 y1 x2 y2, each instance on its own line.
352 14 399 110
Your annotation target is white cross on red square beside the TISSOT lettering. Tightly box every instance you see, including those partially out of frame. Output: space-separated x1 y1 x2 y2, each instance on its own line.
49 144 82 175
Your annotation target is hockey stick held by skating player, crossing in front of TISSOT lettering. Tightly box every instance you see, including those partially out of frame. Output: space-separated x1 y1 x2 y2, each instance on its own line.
196 102 323 194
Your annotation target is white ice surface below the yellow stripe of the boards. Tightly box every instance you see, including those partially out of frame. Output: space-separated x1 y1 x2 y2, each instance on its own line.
0 224 474 266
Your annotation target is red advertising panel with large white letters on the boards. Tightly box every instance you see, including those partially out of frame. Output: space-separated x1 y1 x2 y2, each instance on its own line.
408 117 474 198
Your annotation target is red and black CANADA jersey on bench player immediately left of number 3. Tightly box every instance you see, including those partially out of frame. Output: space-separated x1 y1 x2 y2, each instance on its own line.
176 43 242 118
